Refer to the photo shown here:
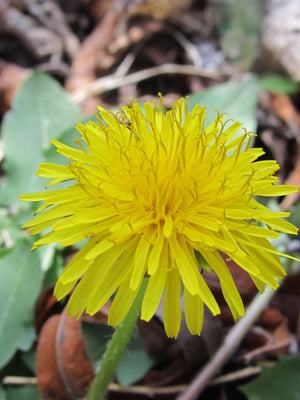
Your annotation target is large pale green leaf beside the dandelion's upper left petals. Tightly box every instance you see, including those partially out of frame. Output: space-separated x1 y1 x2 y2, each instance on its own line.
1 72 82 205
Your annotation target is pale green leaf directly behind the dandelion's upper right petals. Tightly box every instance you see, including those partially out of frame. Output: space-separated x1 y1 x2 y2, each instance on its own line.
188 78 258 132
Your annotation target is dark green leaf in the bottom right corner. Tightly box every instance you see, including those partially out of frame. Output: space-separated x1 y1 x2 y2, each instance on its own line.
239 354 300 400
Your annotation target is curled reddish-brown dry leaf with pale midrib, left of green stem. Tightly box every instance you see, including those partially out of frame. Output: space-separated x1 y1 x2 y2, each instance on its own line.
37 313 94 400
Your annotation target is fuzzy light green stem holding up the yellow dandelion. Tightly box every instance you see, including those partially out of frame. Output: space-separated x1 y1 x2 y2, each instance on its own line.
86 279 147 400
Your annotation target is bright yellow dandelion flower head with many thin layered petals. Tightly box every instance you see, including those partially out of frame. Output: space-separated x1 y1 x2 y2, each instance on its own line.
21 99 297 337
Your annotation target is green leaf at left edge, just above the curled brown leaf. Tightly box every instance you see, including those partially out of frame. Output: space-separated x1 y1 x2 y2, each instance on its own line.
0 240 43 368
